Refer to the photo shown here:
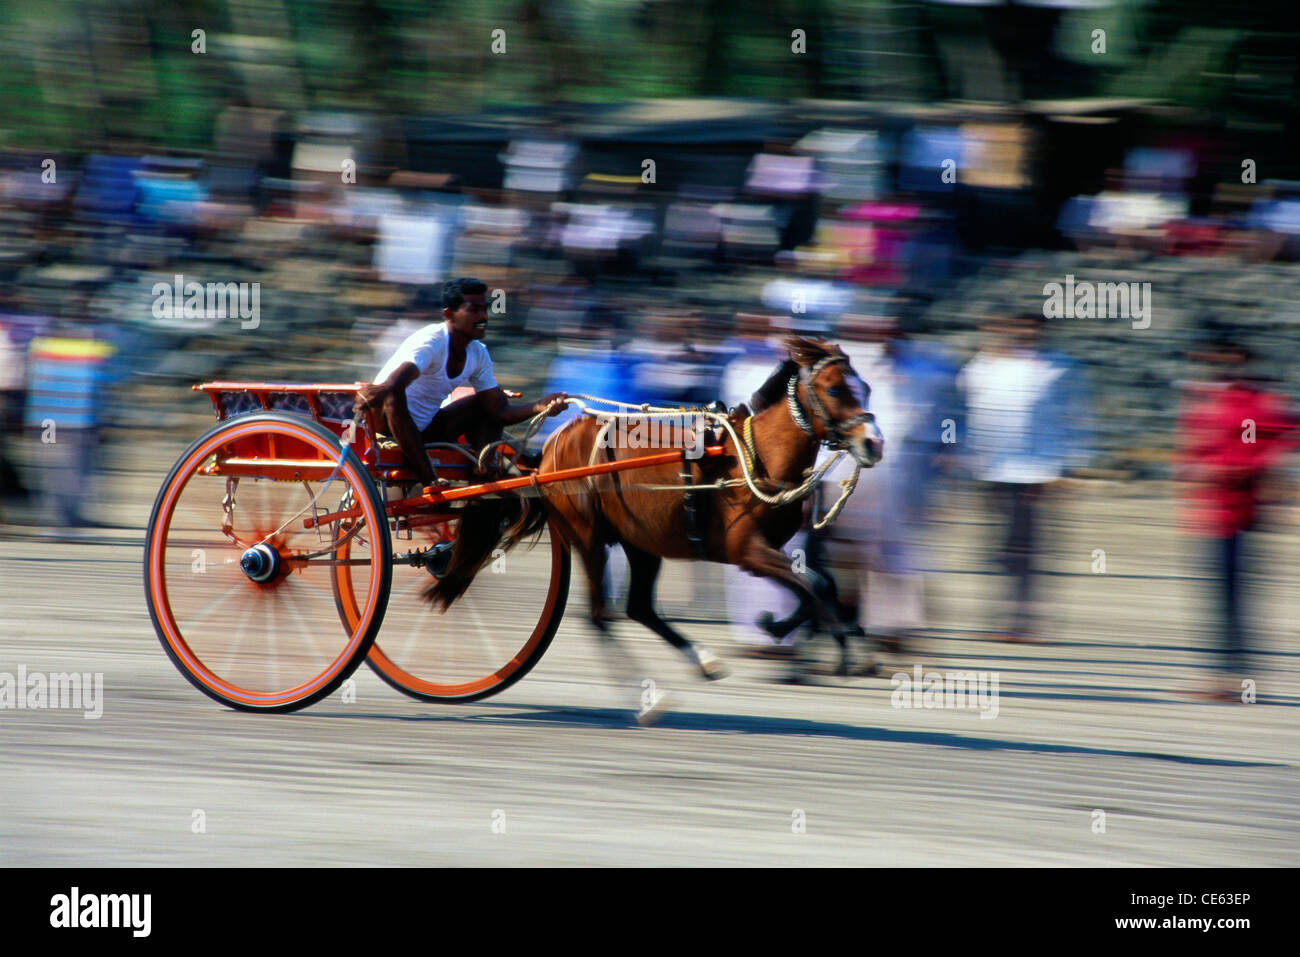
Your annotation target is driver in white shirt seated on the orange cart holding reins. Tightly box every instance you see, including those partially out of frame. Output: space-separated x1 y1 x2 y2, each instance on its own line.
356 277 568 485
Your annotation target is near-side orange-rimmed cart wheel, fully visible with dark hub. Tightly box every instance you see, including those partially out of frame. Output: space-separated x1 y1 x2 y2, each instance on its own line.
144 412 393 711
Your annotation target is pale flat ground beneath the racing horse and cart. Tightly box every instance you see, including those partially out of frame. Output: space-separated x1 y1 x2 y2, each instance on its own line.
0 450 1300 866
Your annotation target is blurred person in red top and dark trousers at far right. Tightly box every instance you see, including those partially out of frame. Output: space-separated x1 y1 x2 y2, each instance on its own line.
1175 326 1296 701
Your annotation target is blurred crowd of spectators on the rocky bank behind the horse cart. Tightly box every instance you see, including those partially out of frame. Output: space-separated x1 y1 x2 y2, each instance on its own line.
0 4 1300 690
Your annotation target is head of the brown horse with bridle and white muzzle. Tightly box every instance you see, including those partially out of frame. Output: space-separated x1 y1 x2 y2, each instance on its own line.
785 335 885 468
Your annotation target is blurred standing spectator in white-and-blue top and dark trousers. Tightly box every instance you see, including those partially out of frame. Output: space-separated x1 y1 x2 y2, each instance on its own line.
956 312 1086 641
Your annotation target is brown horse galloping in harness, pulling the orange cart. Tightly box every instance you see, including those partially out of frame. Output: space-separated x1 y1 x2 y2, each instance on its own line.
426 335 884 679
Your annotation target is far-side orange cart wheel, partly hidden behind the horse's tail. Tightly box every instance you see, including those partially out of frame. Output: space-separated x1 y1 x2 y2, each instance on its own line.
334 516 569 702
